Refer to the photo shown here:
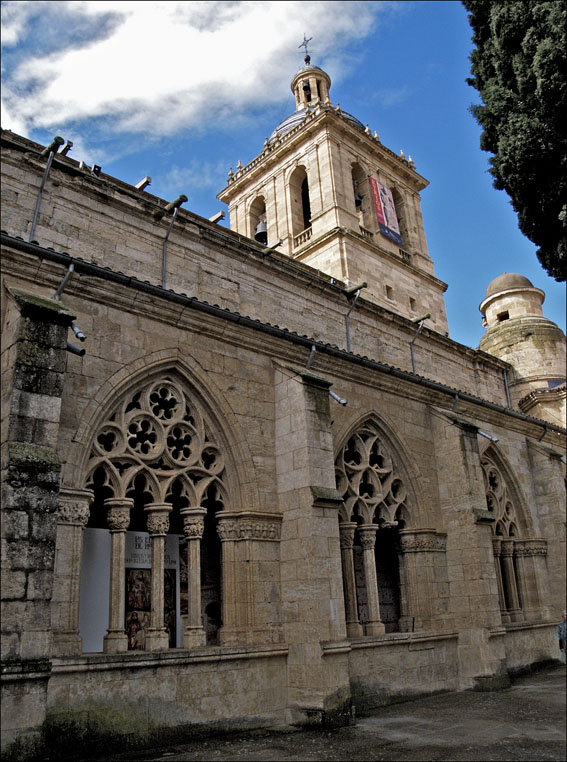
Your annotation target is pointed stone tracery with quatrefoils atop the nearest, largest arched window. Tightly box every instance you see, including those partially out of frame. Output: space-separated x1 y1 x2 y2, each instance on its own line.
89 378 225 505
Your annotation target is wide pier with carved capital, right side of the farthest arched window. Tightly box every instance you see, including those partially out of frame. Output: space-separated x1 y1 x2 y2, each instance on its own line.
514 538 549 622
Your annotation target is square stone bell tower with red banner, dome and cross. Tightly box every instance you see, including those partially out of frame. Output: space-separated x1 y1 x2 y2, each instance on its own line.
217 53 448 333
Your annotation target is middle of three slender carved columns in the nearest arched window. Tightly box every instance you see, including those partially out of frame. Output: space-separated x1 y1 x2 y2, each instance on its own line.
144 503 171 651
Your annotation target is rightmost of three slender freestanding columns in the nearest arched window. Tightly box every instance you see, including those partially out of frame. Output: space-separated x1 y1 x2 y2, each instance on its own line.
181 508 207 648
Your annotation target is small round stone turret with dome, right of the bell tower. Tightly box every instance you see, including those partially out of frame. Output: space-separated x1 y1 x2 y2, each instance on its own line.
479 273 566 426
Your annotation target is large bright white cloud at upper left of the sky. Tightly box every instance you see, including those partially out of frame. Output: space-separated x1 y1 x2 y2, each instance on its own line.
4 0 390 135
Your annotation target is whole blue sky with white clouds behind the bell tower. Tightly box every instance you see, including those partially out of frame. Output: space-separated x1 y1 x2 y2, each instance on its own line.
2 0 565 347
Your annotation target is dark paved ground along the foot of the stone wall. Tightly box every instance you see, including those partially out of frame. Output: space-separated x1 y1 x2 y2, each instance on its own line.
105 665 566 762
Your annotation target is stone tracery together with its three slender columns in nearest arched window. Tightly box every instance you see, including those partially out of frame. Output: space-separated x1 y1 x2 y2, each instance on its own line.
82 376 228 652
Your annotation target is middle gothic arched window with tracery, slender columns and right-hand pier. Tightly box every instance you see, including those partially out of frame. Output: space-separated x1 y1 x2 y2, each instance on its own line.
335 412 446 637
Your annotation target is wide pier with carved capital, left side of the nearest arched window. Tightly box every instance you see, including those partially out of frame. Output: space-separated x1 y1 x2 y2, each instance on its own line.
51 487 93 656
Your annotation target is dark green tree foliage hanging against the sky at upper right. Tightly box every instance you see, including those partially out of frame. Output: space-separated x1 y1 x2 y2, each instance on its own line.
463 0 567 281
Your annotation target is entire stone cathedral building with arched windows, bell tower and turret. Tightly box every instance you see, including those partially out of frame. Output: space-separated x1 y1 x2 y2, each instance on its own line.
1 55 566 757
